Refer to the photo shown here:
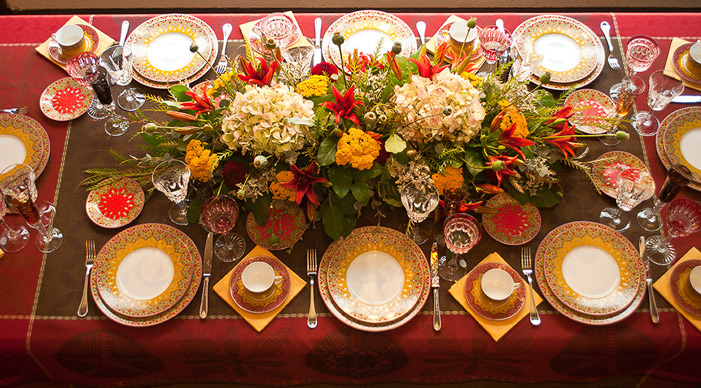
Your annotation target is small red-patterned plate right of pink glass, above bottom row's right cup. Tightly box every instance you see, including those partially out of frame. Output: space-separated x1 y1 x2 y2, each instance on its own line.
482 193 540 245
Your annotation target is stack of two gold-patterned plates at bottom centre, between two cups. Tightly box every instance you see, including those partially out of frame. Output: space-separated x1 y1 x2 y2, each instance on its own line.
318 227 430 331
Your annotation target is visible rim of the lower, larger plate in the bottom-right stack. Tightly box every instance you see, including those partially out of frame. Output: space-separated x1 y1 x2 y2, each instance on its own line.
534 221 645 326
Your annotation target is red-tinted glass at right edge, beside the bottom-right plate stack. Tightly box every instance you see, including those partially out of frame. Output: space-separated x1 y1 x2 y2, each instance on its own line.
645 198 701 265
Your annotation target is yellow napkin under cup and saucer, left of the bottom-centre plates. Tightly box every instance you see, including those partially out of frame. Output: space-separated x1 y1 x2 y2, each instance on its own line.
212 246 307 331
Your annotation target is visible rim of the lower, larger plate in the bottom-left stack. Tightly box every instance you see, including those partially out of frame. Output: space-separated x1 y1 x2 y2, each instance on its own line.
90 224 202 327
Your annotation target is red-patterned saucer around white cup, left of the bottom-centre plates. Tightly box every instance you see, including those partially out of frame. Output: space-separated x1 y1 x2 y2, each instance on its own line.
229 256 292 314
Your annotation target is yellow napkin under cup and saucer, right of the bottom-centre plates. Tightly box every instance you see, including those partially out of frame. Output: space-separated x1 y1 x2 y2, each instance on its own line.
448 252 543 341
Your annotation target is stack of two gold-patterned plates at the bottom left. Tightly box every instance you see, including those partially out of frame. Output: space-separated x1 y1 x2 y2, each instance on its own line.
90 224 202 327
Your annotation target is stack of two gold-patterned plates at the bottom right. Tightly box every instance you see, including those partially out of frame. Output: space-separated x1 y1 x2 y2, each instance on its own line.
535 221 645 325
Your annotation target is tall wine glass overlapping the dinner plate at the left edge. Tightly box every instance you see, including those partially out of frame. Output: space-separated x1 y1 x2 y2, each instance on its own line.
0 164 63 253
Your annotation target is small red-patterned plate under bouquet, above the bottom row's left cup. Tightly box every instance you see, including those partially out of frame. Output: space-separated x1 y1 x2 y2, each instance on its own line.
246 199 307 251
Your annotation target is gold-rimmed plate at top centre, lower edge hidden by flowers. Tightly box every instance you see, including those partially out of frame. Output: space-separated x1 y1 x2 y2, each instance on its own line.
321 10 416 67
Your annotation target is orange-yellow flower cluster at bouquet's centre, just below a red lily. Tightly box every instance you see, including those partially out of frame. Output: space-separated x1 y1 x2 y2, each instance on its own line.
336 128 380 170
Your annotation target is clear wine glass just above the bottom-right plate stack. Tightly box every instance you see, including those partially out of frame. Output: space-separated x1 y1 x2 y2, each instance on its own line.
599 168 654 232
